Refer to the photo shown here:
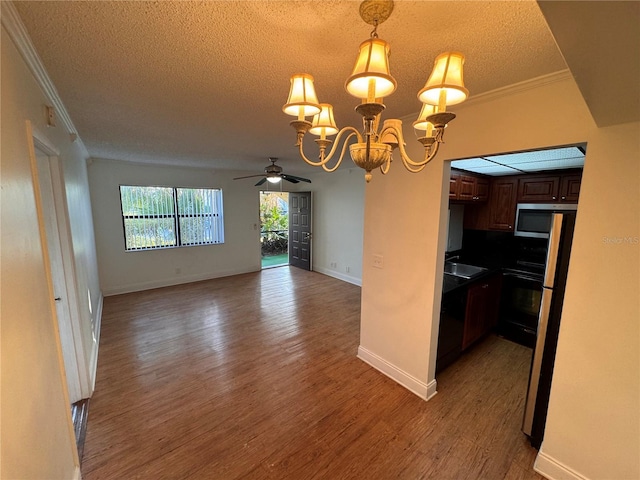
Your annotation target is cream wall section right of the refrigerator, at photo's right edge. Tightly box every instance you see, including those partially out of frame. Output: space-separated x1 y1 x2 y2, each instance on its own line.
538 123 640 480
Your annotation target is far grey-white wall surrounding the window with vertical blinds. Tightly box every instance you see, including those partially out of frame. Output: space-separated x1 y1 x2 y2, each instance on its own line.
89 159 260 295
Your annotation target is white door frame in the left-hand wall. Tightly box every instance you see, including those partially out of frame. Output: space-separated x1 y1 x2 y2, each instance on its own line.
27 122 92 403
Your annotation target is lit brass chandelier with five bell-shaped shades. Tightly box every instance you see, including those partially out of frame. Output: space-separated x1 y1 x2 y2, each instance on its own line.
282 0 469 183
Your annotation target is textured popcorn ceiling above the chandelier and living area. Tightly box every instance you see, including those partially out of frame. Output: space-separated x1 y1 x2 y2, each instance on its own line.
14 0 566 174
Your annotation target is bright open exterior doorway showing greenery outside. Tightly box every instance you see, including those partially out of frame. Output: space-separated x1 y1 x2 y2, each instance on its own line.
260 192 289 269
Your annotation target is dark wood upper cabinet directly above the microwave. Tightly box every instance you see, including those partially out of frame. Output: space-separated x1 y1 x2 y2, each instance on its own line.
517 172 582 203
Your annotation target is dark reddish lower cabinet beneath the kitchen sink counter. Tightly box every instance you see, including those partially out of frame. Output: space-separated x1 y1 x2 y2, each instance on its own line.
462 274 502 350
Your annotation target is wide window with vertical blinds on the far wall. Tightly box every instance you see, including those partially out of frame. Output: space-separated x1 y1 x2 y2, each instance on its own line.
120 185 224 250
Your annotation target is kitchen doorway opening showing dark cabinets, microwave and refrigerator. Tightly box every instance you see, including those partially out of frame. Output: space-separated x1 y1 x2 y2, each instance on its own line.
436 144 586 449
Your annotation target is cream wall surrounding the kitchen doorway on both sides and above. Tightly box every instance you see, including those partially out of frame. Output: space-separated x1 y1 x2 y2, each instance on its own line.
360 72 640 480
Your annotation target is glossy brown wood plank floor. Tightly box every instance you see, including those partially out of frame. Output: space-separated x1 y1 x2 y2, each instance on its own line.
82 267 542 480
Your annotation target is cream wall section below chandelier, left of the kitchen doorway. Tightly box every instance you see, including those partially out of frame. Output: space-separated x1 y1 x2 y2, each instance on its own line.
358 156 450 398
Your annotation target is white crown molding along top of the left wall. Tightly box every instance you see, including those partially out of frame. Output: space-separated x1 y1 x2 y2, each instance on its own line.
0 1 89 157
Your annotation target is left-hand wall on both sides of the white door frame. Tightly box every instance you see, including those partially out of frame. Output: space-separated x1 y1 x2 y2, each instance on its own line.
0 23 101 479
